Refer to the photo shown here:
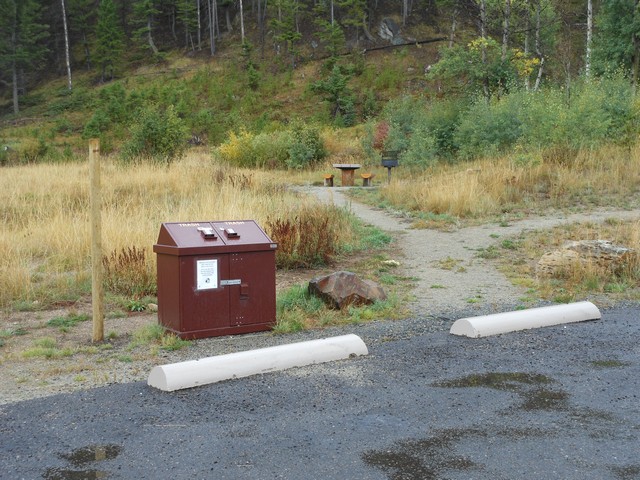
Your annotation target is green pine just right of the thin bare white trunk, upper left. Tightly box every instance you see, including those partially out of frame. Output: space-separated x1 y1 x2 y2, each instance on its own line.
95 0 124 82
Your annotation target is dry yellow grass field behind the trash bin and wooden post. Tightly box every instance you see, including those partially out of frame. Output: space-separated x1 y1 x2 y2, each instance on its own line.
0 155 328 305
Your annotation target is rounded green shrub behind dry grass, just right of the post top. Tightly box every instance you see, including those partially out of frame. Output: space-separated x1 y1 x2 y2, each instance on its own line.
122 105 189 163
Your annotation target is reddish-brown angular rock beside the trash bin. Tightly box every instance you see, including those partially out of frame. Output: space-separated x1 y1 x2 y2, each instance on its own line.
309 271 387 309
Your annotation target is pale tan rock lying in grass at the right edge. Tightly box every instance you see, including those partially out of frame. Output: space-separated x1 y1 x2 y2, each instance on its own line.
536 240 636 277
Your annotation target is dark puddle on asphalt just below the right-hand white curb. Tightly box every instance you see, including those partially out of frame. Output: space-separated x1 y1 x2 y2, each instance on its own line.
434 372 569 411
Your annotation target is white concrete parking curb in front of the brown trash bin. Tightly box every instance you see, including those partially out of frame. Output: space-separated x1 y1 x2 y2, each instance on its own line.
147 334 369 392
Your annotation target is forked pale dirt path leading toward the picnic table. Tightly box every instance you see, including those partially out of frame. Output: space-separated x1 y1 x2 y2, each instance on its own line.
308 187 640 316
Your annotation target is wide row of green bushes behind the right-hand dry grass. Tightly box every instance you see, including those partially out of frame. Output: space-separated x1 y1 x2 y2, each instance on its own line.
364 73 640 168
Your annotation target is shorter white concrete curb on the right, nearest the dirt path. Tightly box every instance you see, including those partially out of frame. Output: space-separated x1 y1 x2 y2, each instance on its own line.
449 302 602 338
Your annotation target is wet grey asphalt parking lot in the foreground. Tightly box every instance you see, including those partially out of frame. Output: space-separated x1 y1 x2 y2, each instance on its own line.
0 305 640 480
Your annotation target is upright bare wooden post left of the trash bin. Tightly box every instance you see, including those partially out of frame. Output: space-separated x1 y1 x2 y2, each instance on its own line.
89 138 104 342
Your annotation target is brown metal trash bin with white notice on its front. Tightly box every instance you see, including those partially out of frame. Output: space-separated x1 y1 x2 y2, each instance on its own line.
153 220 277 339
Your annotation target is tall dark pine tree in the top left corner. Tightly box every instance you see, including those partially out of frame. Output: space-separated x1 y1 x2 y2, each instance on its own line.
0 0 49 114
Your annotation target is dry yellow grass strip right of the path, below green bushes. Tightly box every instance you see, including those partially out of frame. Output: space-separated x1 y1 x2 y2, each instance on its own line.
381 147 640 218
